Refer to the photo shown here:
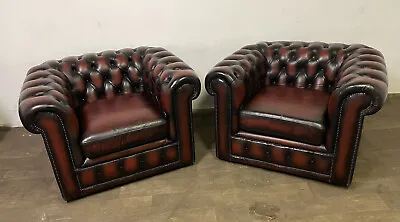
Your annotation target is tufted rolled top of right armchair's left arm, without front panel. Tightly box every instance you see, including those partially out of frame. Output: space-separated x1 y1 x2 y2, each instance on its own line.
205 45 266 108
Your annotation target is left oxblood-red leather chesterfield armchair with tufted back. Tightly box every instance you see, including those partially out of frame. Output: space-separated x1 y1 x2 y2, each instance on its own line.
19 47 200 201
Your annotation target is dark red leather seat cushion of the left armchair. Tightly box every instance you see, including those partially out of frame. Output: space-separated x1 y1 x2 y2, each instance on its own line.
81 93 168 158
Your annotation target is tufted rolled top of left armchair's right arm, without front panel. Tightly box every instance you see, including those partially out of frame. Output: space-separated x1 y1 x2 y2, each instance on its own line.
143 47 201 115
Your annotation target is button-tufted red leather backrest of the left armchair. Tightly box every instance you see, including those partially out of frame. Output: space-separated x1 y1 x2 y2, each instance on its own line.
28 47 147 107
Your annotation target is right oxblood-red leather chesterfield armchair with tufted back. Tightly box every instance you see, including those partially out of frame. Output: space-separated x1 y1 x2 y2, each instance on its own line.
205 42 388 187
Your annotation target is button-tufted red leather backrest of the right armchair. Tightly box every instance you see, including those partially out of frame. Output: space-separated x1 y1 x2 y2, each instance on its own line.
258 42 358 92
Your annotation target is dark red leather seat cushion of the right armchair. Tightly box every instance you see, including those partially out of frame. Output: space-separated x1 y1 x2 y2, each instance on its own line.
240 86 329 145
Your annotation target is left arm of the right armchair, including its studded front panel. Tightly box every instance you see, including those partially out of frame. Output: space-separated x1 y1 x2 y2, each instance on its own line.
205 45 266 160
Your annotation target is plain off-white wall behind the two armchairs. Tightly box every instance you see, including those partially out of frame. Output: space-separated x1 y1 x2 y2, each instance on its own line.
0 0 400 126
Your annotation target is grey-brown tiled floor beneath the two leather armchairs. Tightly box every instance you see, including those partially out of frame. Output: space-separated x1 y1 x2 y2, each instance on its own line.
0 96 400 222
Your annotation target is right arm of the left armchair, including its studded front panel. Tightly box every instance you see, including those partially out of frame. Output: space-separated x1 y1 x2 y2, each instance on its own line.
143 47 200 150
